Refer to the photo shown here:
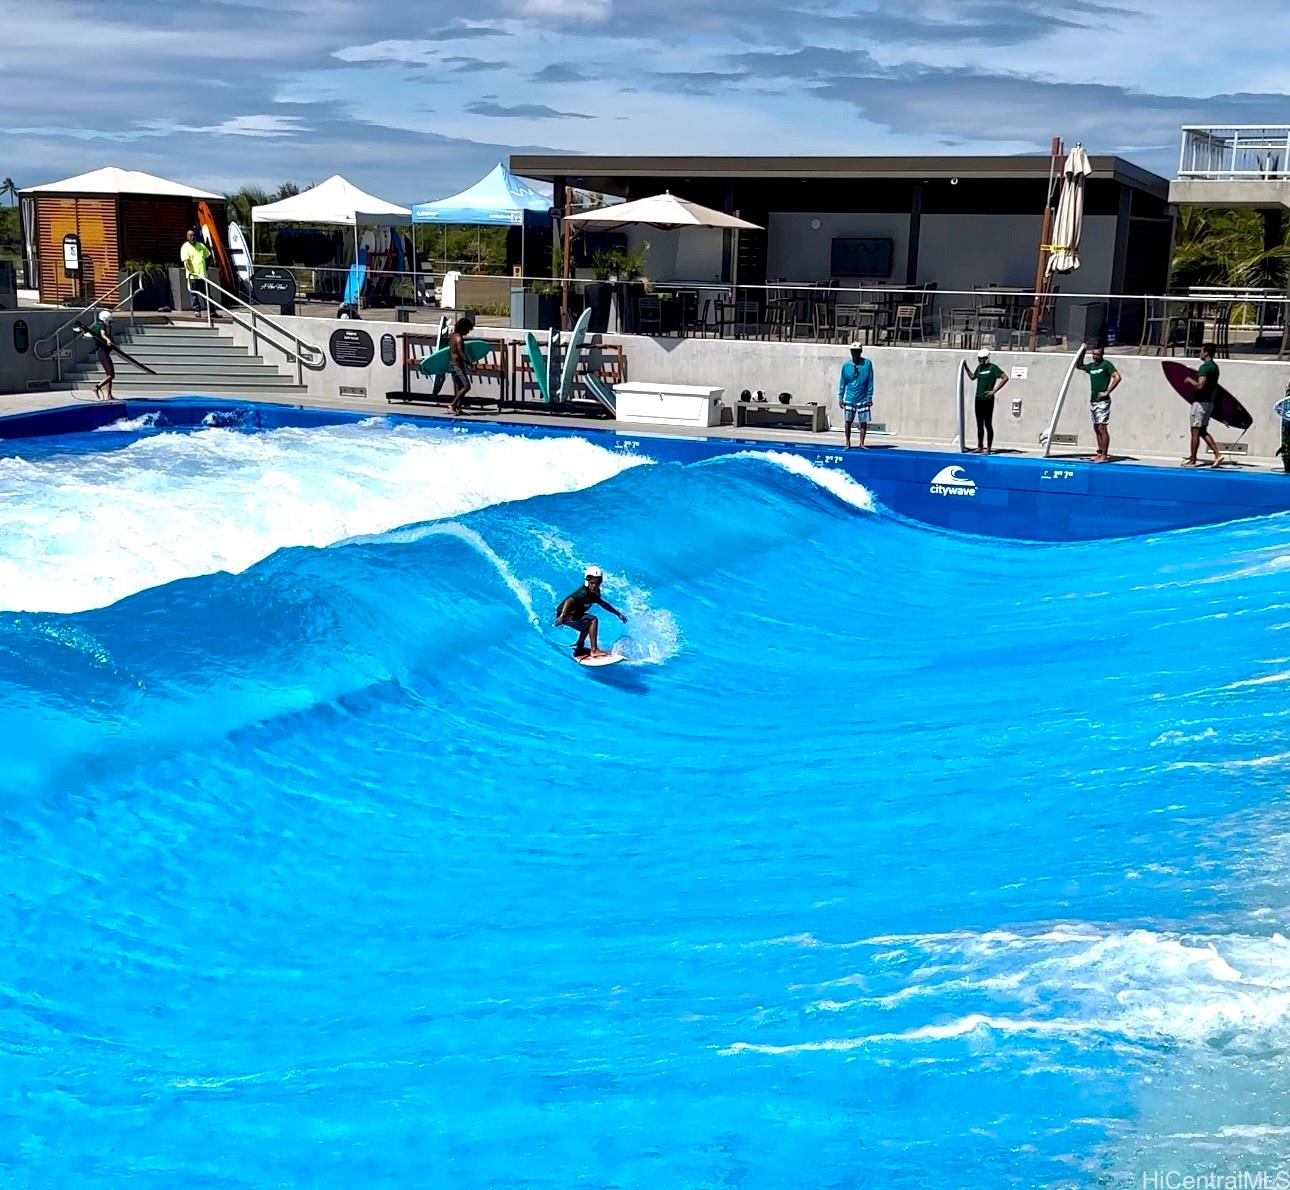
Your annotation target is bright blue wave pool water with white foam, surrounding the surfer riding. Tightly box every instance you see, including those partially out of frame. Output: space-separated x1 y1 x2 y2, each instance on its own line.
0 422 1290 1187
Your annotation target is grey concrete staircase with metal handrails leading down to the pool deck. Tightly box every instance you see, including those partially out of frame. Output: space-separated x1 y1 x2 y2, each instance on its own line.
63 323 304 396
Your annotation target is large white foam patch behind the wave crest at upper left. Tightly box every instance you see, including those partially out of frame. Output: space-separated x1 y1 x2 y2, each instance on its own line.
0 418 648 612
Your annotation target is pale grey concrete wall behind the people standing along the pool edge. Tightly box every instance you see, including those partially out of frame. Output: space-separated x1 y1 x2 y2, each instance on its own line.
221 308 1290 459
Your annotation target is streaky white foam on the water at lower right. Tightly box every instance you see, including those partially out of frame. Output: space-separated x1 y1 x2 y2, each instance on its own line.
722 925 1290 1054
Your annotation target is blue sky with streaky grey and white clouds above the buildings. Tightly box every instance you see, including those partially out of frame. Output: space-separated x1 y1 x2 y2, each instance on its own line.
0 0 1290 203
